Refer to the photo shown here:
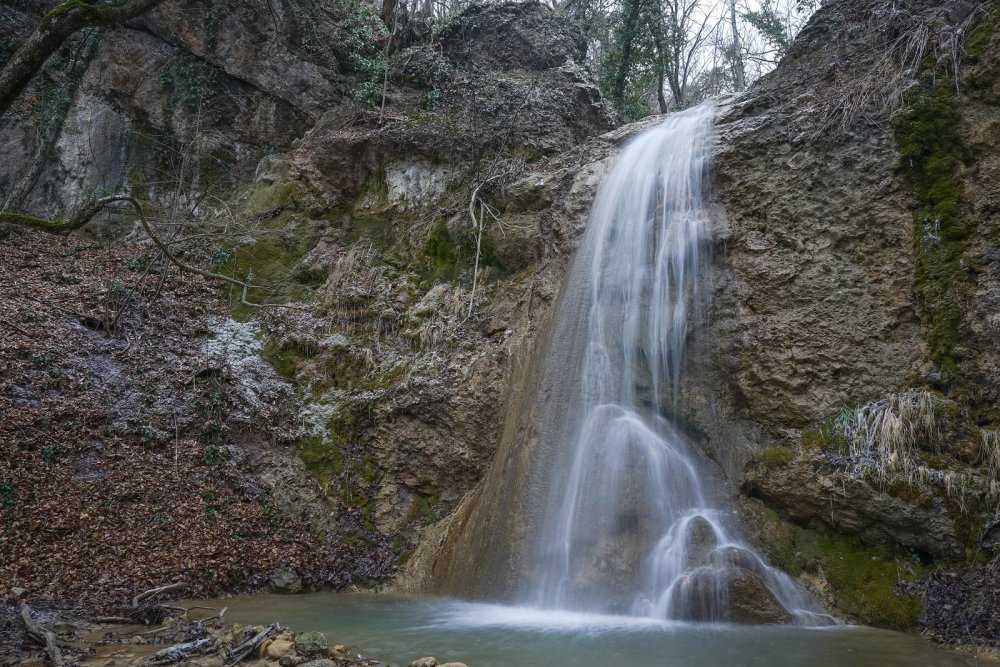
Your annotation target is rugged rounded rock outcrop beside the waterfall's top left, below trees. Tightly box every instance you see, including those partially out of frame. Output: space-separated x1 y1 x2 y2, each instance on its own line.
290 3 611 208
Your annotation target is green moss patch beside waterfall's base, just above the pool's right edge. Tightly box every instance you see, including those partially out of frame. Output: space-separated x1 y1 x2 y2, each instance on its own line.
746 500 928 630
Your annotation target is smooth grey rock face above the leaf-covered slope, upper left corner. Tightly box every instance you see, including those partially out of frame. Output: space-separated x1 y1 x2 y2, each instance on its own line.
0 0 347 215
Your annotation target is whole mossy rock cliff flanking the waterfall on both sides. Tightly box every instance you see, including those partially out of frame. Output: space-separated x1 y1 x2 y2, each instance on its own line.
0 0 1000 644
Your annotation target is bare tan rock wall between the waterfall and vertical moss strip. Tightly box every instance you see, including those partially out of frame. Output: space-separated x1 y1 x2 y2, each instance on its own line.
708 3 930 431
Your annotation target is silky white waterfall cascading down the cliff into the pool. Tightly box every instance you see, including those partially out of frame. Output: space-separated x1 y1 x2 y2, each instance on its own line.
524 105 833 624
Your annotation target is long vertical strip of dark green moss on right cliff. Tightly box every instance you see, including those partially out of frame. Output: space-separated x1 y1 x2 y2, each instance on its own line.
893 78 971 371
